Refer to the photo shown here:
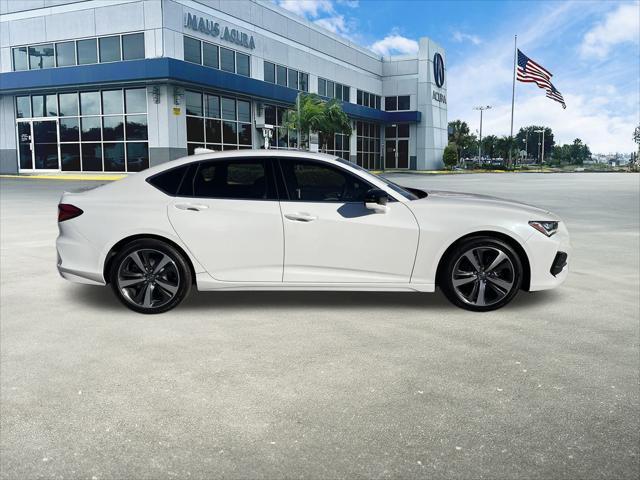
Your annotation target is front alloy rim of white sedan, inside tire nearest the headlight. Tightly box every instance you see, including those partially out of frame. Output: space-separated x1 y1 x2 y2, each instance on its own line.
451 246 516 307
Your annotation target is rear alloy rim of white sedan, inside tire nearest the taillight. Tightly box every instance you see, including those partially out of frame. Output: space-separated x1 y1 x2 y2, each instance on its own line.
117 249 180 308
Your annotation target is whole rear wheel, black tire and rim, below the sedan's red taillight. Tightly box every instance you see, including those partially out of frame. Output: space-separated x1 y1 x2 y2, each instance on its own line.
109 238 192 314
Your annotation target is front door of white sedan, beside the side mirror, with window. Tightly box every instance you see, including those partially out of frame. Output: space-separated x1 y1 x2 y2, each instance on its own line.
279 158 418 283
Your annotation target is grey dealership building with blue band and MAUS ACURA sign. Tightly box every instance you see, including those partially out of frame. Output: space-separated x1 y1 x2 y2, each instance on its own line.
0 0 447 173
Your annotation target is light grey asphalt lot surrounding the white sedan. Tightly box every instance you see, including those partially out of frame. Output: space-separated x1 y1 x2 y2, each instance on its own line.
0 174 640 479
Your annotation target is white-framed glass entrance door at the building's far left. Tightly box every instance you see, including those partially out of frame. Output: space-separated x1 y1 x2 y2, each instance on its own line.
18 120 60 170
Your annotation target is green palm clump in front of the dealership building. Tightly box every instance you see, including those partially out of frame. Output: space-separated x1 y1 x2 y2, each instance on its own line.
283 93 351 149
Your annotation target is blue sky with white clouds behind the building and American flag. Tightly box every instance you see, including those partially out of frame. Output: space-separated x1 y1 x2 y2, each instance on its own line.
273 0 640 153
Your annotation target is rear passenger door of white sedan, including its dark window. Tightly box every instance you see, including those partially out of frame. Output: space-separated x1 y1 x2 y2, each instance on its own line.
168 158 284 282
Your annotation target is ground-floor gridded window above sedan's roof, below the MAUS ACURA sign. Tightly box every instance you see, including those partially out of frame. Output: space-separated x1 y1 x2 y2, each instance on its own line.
185 90 252 155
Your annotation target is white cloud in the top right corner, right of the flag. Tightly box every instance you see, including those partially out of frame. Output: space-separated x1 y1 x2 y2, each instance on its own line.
580 3 640 58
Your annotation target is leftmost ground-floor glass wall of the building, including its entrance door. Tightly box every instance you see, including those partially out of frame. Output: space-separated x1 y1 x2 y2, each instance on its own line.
16 88 149 172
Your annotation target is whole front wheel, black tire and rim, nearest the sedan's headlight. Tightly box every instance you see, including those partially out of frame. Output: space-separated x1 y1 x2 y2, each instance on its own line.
438 236 523 312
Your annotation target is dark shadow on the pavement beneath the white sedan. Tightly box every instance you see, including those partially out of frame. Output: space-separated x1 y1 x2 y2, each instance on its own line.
70 285 562 312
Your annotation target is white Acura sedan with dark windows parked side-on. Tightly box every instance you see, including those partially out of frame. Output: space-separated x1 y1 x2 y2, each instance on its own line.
56 150 570 313
